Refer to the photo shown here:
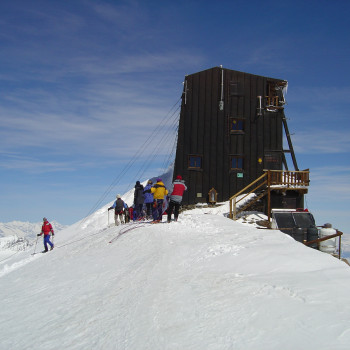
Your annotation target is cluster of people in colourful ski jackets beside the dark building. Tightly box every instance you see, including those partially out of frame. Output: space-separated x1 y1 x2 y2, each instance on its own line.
108 175 187 225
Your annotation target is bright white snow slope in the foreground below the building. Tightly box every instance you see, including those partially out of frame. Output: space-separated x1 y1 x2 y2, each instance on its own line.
0 205 350 350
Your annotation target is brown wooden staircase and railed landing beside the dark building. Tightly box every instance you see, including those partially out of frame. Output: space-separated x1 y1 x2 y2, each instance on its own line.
230 169 310 221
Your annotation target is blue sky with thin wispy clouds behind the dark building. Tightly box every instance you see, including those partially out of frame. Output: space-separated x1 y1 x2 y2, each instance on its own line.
0 0 350 233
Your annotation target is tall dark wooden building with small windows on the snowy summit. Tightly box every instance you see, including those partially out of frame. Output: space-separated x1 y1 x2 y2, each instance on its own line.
174 67 303 206
